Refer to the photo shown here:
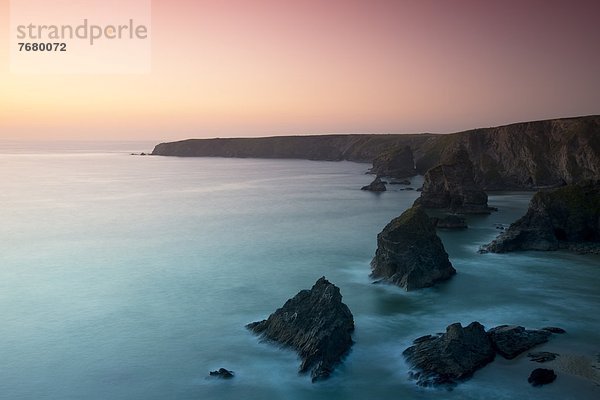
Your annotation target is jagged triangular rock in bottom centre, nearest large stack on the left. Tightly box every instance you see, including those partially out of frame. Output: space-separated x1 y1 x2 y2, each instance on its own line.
246 277 354 382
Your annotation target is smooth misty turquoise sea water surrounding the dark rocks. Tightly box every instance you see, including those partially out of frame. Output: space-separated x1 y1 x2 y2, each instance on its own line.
0 142 600 400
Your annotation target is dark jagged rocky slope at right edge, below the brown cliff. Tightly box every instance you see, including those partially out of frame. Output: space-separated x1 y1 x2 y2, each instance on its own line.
481 181 600 253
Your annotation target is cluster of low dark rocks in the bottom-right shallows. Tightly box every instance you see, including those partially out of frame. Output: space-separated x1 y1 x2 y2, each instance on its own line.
403 321 564 386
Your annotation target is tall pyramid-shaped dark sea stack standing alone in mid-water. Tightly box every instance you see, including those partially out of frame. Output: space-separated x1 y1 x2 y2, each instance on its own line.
371 206 456 290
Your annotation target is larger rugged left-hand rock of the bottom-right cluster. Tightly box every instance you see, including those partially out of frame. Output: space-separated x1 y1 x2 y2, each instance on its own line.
403 322 495 386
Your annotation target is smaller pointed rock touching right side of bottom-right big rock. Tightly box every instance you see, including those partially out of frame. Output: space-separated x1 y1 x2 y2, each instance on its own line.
488 325 551 360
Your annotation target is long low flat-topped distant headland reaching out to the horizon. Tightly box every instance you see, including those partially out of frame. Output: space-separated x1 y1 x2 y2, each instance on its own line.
152 134 434 162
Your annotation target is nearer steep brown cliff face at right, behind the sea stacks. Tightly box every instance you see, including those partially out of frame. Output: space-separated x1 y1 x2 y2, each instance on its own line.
416 115 600 190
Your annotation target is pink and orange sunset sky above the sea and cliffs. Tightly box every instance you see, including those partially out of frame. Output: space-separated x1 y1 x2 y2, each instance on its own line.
0 0 600 140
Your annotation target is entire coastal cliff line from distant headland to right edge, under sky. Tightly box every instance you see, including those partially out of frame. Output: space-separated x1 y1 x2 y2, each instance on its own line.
152 115 600 190
